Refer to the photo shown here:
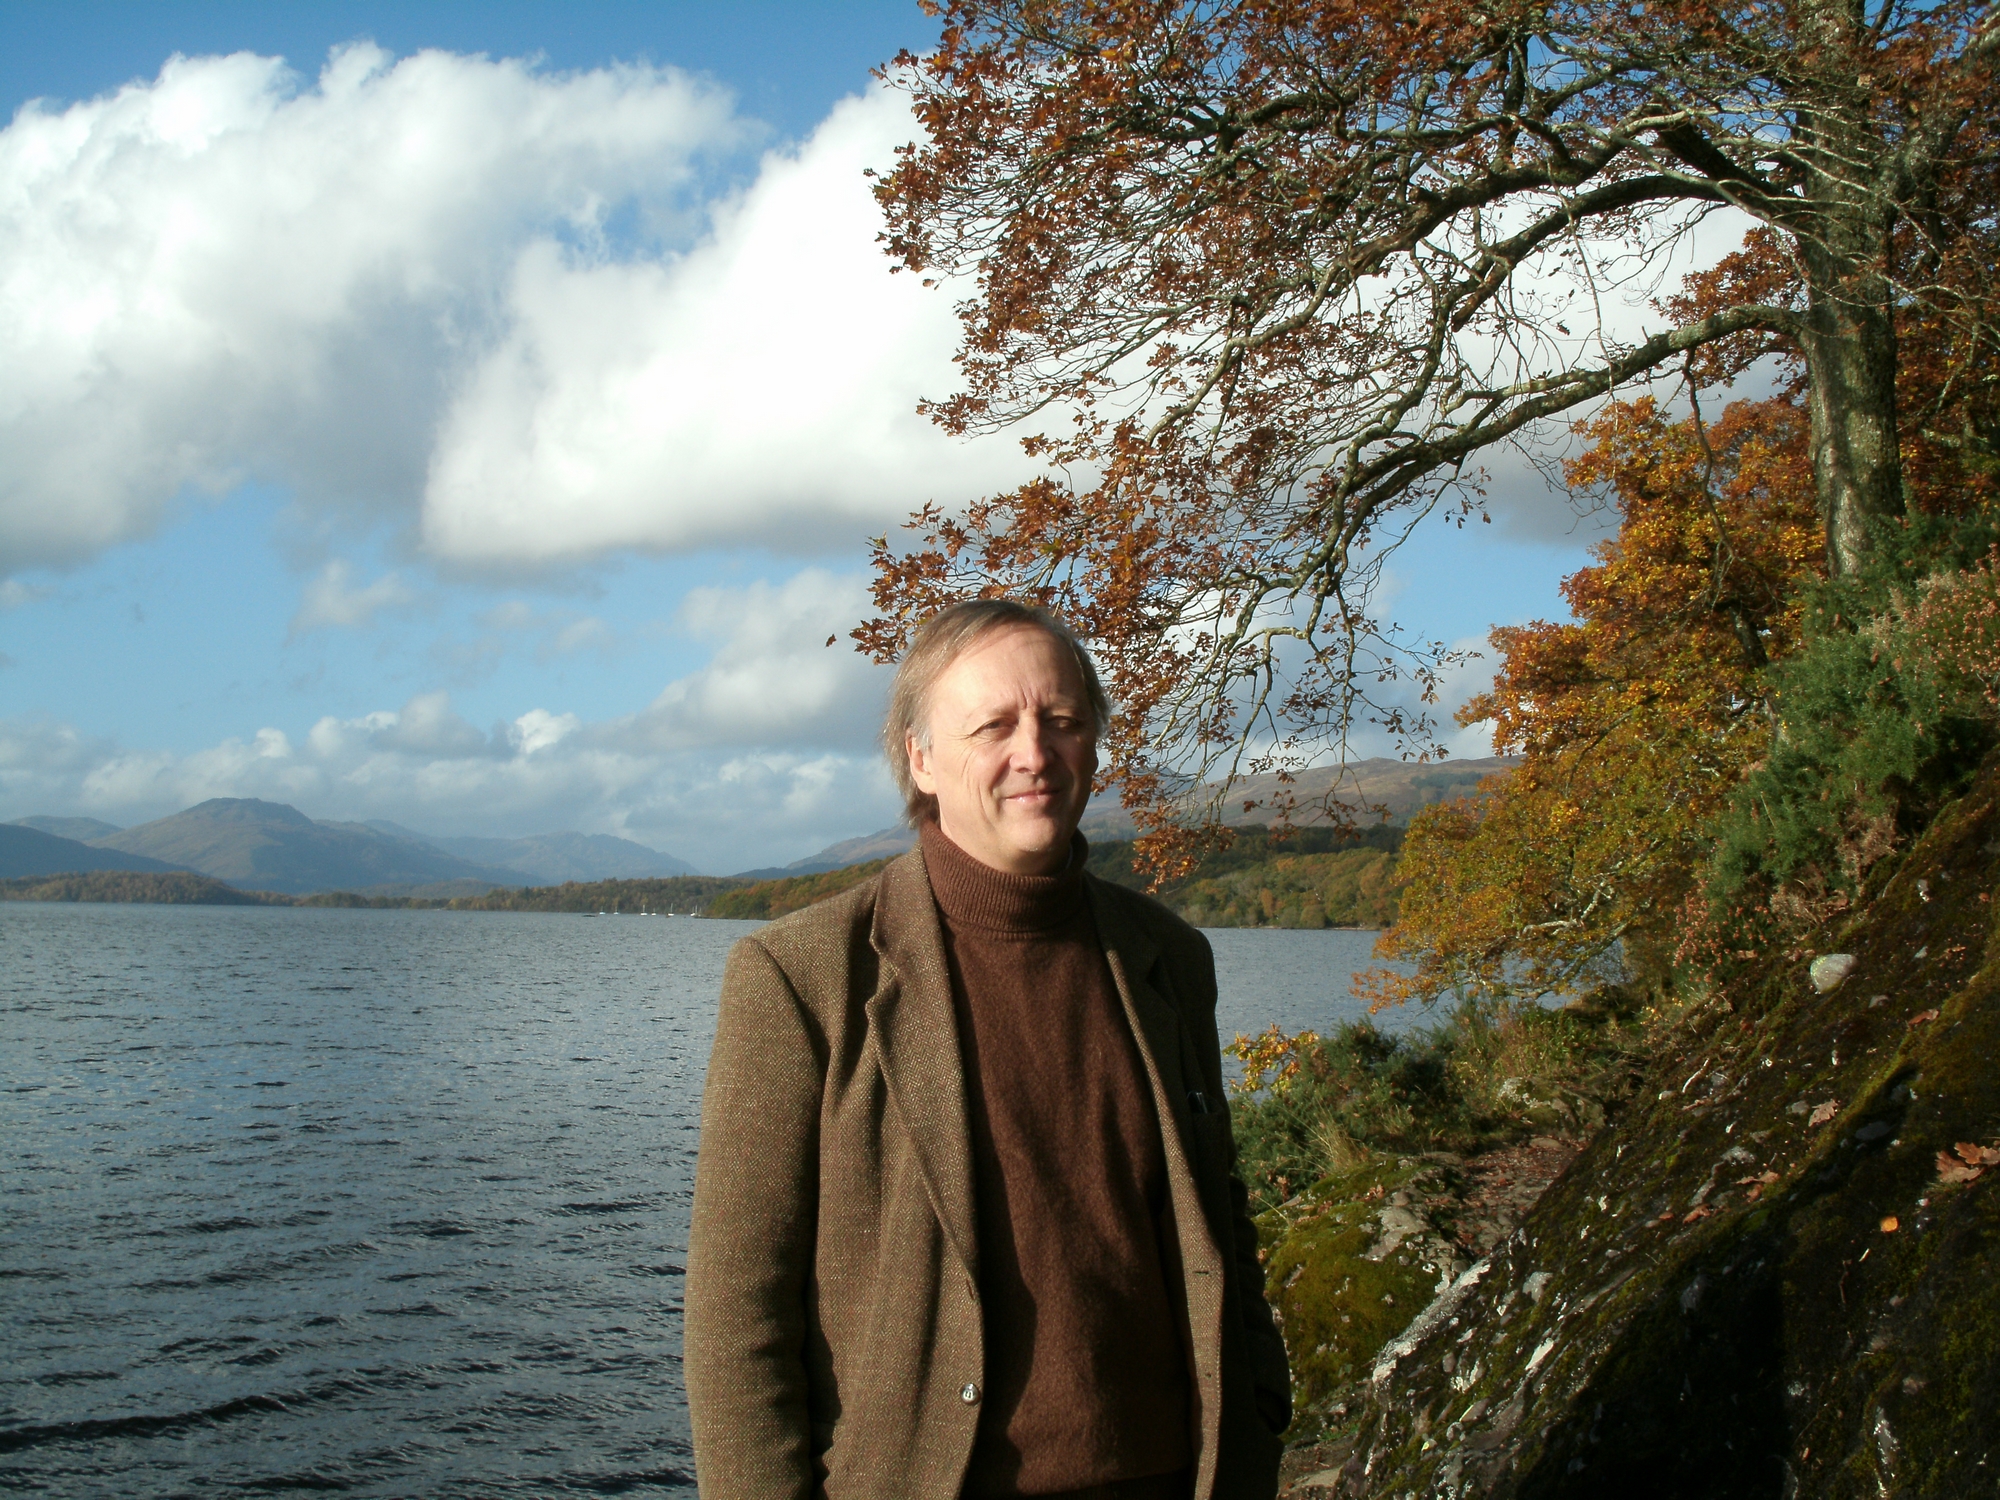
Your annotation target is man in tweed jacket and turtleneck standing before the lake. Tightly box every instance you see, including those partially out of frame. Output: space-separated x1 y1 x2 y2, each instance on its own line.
686 600 1290 1500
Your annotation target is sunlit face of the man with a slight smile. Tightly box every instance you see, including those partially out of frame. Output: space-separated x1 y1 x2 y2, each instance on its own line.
908 626 1098 874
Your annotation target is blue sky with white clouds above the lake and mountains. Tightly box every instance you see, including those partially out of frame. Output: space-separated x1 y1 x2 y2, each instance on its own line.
0 0 1588 870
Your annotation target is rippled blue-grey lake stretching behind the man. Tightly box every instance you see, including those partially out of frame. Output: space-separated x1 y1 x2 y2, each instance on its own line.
0 902 1414 1496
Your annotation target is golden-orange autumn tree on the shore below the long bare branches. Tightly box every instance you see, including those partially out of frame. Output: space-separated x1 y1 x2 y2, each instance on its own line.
1364 398 1822 1004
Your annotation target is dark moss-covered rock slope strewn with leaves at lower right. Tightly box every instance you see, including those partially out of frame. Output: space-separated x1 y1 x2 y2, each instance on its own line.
1312 766 2000 1500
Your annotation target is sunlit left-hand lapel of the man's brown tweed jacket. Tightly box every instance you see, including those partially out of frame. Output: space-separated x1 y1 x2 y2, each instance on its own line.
868 850 978 1278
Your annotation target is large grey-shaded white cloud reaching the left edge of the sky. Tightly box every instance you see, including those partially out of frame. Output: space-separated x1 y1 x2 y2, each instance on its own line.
0 46 740 574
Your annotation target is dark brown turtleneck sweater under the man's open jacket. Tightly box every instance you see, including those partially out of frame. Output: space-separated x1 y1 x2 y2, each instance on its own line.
922 822 1192 1500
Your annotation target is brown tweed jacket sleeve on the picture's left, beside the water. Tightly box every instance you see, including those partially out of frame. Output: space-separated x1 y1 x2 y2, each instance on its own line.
684 938 826 1500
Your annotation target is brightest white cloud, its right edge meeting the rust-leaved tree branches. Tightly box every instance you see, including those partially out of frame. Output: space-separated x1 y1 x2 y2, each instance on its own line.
424 90 1026 562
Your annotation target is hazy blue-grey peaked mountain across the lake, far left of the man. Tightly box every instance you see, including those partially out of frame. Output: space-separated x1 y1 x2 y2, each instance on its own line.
94 796 520 896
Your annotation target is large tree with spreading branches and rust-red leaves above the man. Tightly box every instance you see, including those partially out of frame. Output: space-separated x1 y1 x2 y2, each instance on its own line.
860 0 2000 856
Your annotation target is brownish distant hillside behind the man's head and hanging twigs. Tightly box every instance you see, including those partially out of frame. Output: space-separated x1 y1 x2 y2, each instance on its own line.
764 756 1520 880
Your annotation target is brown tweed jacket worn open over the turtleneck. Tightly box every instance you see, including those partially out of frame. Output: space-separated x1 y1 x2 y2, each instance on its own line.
686 852 1290 1500
